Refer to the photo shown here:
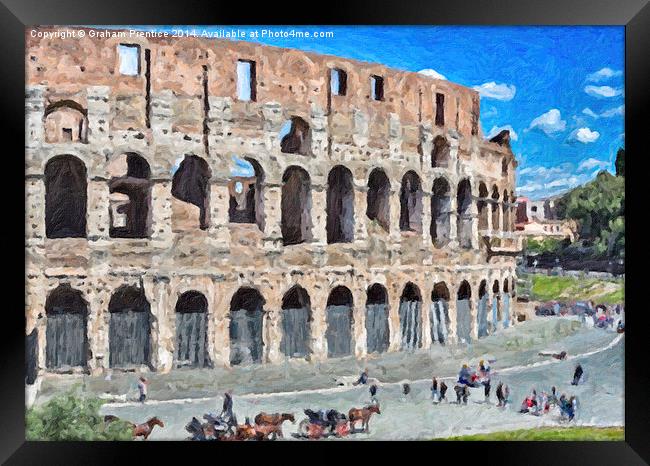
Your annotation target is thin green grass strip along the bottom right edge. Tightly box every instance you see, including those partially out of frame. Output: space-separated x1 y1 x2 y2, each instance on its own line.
436 427 625 442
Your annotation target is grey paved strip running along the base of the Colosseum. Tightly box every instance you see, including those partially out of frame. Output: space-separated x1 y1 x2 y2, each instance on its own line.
37 317 612 403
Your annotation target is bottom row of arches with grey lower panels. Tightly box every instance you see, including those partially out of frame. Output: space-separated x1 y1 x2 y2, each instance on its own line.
45 279 514 369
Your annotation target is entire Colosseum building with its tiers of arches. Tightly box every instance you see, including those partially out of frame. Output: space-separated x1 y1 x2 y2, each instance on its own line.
25 28 520 374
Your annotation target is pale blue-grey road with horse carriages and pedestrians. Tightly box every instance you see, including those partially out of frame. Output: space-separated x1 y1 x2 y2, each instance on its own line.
92 320 624 440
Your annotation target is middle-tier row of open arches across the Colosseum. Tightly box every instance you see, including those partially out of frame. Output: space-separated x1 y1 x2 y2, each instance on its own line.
44 153 514 248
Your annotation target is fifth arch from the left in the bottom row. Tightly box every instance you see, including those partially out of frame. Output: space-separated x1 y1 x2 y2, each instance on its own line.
280 285 311 358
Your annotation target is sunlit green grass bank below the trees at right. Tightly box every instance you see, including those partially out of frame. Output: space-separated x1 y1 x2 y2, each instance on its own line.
531 274 625 304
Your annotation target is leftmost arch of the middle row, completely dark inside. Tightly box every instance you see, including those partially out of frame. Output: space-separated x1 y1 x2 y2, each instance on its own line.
45 155 88 238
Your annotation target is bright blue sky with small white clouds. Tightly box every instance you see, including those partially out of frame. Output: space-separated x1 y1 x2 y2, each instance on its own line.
125 26 625 199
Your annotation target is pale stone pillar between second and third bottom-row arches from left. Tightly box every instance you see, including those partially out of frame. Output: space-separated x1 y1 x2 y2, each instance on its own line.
143 275 176 372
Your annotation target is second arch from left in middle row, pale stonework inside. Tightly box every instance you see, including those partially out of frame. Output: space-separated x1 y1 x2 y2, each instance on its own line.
108 153 151 238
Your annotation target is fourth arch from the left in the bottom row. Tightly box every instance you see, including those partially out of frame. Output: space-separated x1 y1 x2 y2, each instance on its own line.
230 288 264 366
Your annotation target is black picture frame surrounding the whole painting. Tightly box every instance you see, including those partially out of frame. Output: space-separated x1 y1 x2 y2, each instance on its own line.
0 0 650 465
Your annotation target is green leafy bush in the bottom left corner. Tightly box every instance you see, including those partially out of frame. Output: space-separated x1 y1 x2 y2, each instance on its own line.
25 392 132 440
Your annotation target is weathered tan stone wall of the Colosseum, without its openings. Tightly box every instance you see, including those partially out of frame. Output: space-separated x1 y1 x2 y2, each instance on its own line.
25 27 516 371
